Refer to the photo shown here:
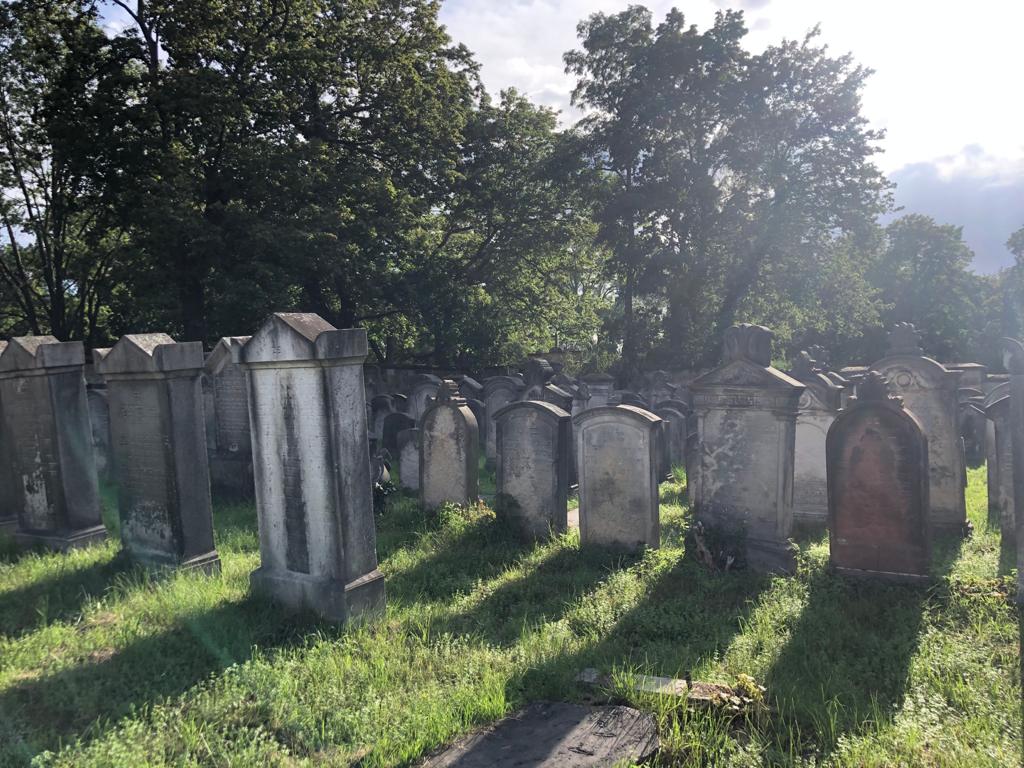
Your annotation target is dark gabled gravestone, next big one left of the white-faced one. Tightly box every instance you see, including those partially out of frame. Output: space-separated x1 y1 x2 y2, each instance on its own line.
92 334 220 570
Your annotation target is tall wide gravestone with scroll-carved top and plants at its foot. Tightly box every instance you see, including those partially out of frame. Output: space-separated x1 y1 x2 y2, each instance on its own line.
689 325 806 570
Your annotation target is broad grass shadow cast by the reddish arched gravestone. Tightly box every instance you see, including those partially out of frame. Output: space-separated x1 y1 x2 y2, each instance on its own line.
765 570 928 759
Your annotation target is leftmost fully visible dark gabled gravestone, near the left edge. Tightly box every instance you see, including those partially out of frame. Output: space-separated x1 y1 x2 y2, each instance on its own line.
0 336 106 550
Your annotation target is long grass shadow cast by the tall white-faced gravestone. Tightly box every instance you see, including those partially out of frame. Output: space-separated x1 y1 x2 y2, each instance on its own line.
0 597 318 765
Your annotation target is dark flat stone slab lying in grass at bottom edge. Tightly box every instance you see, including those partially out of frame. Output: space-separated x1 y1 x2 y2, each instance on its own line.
423 701 658 768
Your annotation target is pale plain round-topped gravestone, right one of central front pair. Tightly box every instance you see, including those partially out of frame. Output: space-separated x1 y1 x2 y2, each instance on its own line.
572 406 662 552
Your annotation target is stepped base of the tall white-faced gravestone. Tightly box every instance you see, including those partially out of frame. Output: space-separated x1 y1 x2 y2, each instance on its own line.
249 568 384 623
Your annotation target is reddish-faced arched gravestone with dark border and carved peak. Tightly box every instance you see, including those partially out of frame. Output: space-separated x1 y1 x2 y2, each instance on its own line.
826 371 930 580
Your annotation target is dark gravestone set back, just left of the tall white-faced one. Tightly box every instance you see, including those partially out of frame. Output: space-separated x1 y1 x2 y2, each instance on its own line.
205 336 256 499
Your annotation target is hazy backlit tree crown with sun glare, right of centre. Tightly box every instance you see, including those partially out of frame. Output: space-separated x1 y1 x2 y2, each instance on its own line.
565 6 889 377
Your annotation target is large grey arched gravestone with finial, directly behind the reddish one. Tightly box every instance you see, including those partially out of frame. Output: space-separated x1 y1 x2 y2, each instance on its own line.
871 323 967 532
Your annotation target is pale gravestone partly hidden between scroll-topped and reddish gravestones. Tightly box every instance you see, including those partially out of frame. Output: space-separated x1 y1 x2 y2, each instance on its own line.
791 351 843 529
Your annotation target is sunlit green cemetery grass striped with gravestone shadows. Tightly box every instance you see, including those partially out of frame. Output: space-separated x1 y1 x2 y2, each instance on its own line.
0 470 1021 766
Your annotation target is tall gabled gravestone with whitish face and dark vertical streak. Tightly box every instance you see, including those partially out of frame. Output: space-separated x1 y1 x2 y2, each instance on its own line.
238 312 384 621
